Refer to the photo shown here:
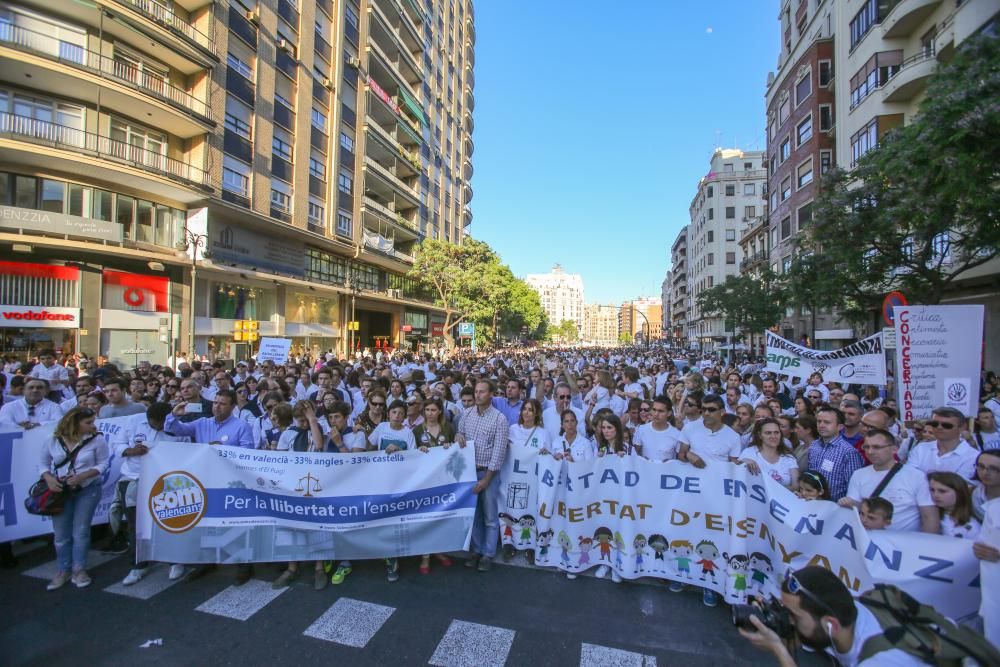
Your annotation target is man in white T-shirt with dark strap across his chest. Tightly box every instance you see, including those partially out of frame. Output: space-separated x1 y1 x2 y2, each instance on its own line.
837 428 941 535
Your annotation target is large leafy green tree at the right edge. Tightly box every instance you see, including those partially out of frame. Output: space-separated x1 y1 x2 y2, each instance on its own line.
804 35 1000 323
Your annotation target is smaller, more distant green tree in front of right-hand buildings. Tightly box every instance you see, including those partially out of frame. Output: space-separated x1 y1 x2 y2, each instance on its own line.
698 270 782 348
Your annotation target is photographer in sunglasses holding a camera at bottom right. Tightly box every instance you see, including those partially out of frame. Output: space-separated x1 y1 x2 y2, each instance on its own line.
739 565 926 667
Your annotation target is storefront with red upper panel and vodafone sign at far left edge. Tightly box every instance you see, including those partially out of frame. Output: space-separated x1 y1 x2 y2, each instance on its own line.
0 261 80 359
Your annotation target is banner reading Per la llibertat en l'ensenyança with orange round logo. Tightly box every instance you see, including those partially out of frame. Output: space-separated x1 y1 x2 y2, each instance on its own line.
136 443 476 563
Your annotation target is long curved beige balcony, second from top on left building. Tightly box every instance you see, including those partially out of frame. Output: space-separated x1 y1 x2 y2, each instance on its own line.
0 26 215 138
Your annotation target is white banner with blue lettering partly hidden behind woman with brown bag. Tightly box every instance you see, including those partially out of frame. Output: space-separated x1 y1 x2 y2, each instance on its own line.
0 417 128 542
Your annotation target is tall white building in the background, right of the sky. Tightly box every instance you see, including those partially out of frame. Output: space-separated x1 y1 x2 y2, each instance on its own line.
685 148 767 351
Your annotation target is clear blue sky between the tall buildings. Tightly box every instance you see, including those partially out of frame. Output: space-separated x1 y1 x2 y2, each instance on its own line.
471 0 779 303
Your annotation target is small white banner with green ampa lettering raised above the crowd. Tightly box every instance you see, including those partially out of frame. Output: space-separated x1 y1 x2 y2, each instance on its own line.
764 331 885 386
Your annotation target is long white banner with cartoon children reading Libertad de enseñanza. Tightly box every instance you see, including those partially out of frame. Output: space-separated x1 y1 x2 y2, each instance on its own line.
498 446 980 618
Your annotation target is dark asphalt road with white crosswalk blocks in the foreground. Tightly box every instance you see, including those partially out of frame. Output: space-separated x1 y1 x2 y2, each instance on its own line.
0 545 823 667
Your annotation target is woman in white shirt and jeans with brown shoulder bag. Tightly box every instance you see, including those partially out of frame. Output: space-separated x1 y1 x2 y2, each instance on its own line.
38 407 109 591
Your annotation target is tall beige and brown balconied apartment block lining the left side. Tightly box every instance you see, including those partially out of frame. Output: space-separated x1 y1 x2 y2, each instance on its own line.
0 0 475 365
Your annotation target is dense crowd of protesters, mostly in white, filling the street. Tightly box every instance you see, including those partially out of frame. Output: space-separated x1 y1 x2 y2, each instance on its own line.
0 347 1000 664
